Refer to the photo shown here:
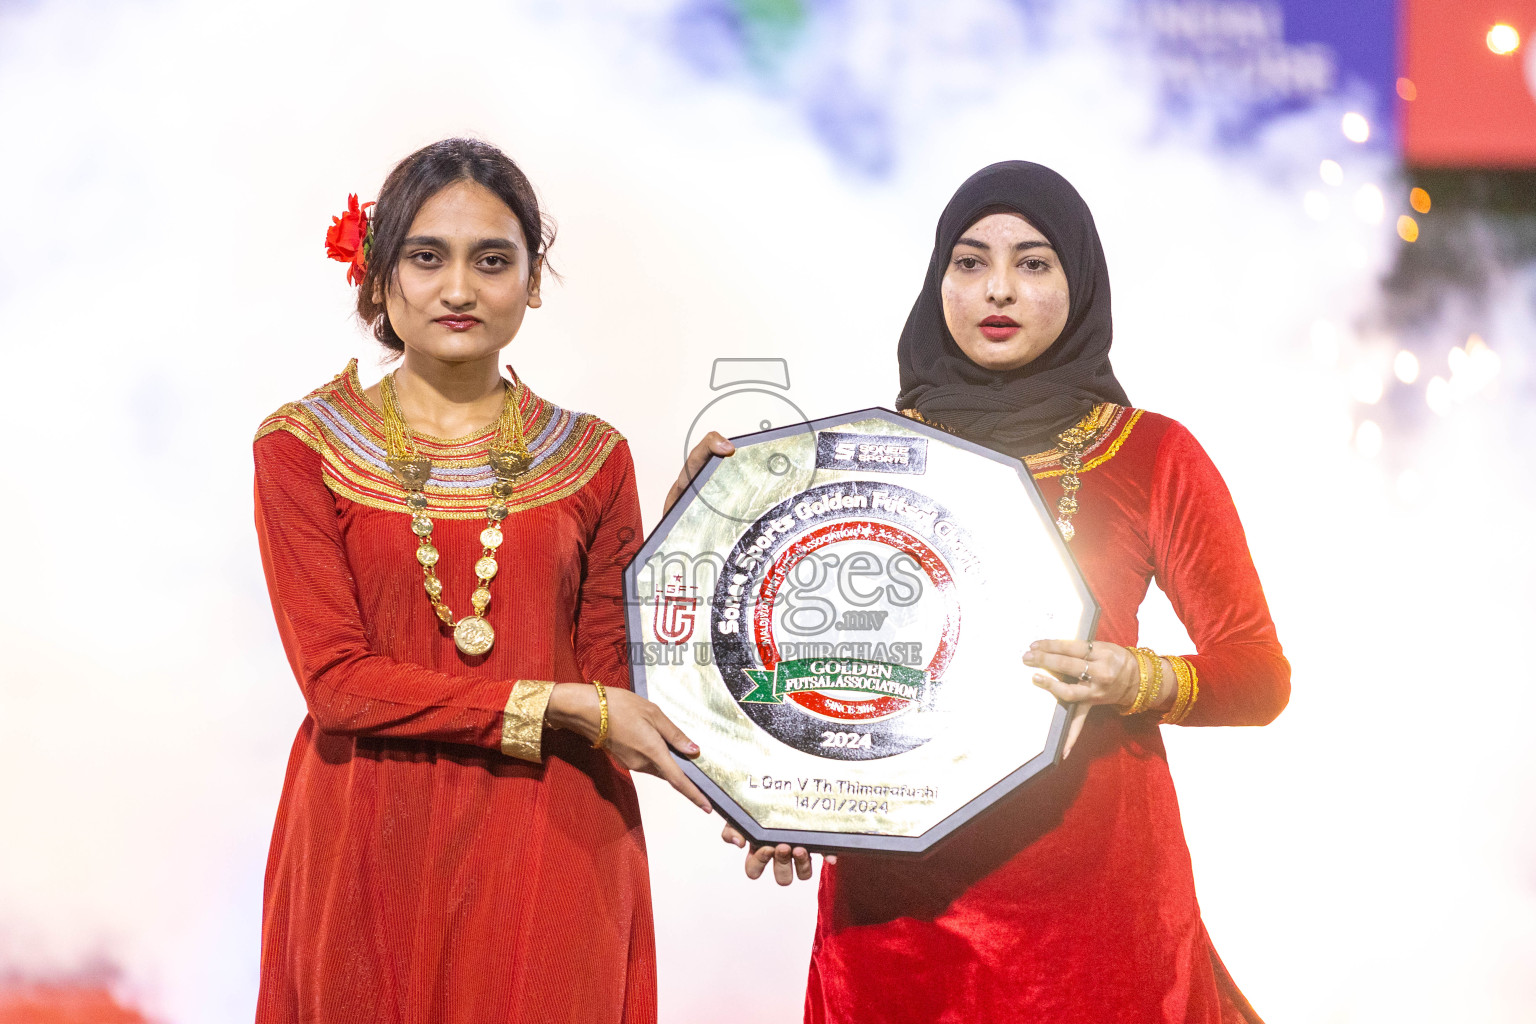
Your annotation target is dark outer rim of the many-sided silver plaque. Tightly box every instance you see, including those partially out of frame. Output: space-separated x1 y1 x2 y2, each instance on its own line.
624 405 1101 855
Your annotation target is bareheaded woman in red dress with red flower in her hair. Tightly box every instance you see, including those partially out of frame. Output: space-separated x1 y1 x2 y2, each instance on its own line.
255 140 708 1024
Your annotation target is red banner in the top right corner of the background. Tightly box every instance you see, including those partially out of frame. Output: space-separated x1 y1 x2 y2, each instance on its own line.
1398 0 1536 169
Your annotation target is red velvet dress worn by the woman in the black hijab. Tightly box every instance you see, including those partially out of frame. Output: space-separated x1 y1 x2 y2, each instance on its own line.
805 405 1290 1024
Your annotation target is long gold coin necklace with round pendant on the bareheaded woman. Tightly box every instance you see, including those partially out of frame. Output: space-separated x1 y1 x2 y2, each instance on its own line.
379 373 533 657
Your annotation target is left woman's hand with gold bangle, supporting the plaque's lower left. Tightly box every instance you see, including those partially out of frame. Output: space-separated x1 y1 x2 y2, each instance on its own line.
544 683 713 814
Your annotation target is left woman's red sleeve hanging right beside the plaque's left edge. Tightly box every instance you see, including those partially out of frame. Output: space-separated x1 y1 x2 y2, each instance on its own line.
576 441 644 689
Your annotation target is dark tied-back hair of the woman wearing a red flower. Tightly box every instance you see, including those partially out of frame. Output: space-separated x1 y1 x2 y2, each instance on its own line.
358 138 554 352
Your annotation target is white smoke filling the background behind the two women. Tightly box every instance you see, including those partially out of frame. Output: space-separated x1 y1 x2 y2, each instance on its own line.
0 0 1536 1024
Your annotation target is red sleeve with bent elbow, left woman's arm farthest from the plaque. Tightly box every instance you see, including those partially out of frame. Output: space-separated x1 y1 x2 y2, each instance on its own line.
255 430 528 749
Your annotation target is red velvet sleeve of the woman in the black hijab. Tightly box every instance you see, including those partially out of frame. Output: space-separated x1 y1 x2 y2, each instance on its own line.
1147 424 1290 725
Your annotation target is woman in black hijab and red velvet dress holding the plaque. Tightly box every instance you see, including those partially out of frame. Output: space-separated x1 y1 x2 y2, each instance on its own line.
700 161 1290 1024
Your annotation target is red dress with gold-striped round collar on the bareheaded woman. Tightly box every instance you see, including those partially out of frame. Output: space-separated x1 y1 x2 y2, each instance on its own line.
255 364 656 1024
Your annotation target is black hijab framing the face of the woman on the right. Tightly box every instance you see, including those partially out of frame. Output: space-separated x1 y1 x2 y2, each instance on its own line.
895 160 1130 459
